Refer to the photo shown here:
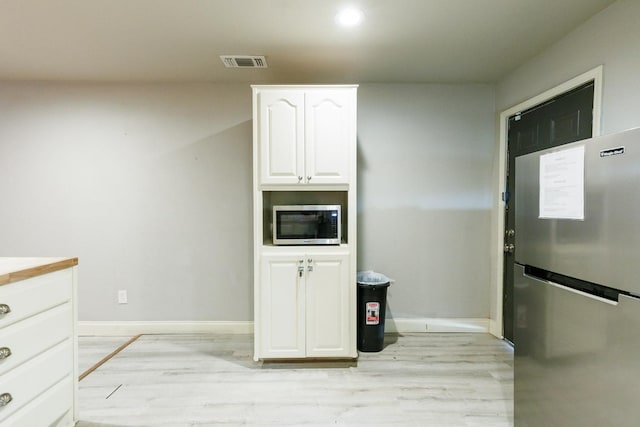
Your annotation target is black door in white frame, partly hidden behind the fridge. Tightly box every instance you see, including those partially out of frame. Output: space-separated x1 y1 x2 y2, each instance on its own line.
503 81 594 345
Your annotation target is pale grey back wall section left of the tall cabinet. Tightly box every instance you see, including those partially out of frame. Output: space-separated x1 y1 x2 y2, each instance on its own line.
0 83 253 320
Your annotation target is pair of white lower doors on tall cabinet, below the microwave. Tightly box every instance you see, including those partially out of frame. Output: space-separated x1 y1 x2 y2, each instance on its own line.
256 250 357 359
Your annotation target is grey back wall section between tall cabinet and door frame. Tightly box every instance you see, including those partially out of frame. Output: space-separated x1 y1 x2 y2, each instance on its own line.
358 85 495 318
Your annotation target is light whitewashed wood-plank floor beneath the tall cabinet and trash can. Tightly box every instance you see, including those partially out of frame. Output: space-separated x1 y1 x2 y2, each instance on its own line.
77 333 513 427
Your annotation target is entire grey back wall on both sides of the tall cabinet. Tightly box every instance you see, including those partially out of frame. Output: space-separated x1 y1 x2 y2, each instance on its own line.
0 82 495 321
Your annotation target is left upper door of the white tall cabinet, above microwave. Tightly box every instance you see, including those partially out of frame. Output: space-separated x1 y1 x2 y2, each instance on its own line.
258 90 305 184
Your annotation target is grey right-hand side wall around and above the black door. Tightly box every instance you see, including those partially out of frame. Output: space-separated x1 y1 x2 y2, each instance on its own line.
491 0 640 324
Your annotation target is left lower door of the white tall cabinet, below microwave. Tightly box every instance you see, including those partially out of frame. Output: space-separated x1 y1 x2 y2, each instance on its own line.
256 254 305 359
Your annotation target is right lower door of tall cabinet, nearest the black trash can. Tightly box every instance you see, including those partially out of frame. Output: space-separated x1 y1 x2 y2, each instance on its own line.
305 252 355 357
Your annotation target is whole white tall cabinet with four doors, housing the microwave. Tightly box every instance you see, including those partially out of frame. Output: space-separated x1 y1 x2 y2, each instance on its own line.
252 85 357 360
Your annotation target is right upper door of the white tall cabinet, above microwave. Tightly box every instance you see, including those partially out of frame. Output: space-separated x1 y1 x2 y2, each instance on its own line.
305 89 356 184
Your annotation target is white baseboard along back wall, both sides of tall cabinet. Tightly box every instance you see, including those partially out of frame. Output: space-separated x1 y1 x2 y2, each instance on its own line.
78 317 490 336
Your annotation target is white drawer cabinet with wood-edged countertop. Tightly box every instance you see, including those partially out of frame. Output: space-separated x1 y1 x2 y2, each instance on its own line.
0 258 78 426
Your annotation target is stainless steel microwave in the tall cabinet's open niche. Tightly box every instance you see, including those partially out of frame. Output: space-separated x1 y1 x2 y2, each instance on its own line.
273 205 342 245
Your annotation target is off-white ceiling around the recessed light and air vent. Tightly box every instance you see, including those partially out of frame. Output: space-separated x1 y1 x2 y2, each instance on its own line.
0 0 614 83
